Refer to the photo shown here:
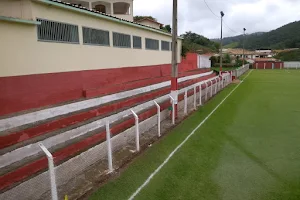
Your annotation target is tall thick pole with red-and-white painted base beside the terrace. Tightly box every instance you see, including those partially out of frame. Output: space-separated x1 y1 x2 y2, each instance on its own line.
171 0 178 117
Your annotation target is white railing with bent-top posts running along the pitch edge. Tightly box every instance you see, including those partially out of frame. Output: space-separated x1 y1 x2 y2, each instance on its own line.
14 73 232 200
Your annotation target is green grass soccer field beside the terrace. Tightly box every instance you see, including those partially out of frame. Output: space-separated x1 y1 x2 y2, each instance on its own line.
89 70 300 200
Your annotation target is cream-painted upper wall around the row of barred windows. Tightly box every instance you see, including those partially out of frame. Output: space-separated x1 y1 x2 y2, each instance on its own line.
0 2 181 77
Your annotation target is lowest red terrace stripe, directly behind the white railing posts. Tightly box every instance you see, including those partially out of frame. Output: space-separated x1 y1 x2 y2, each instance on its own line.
0 75 216 190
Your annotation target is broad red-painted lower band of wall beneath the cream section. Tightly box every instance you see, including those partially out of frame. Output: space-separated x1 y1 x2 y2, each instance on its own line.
0 54 202 116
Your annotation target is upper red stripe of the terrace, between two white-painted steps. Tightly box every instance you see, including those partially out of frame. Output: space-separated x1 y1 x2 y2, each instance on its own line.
0 74 215 149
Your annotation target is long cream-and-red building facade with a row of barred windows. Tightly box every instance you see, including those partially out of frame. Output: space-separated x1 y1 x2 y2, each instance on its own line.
0 0 181 115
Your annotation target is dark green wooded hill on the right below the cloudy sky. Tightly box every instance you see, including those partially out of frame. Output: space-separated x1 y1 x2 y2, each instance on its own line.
214 21 300 50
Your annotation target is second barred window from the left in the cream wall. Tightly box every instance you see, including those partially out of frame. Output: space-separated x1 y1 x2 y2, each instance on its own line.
82 27 109 46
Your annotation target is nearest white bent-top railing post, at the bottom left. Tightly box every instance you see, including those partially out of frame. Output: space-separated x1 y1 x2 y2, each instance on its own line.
39 143 58 200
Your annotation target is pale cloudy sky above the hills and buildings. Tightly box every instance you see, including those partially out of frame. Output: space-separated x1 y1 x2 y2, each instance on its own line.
133 0 300 38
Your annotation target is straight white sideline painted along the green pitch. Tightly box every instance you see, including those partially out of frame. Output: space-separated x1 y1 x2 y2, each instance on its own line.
128 70 252 200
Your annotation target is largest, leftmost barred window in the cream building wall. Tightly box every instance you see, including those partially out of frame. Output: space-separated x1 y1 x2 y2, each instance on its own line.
37 19 79 44
